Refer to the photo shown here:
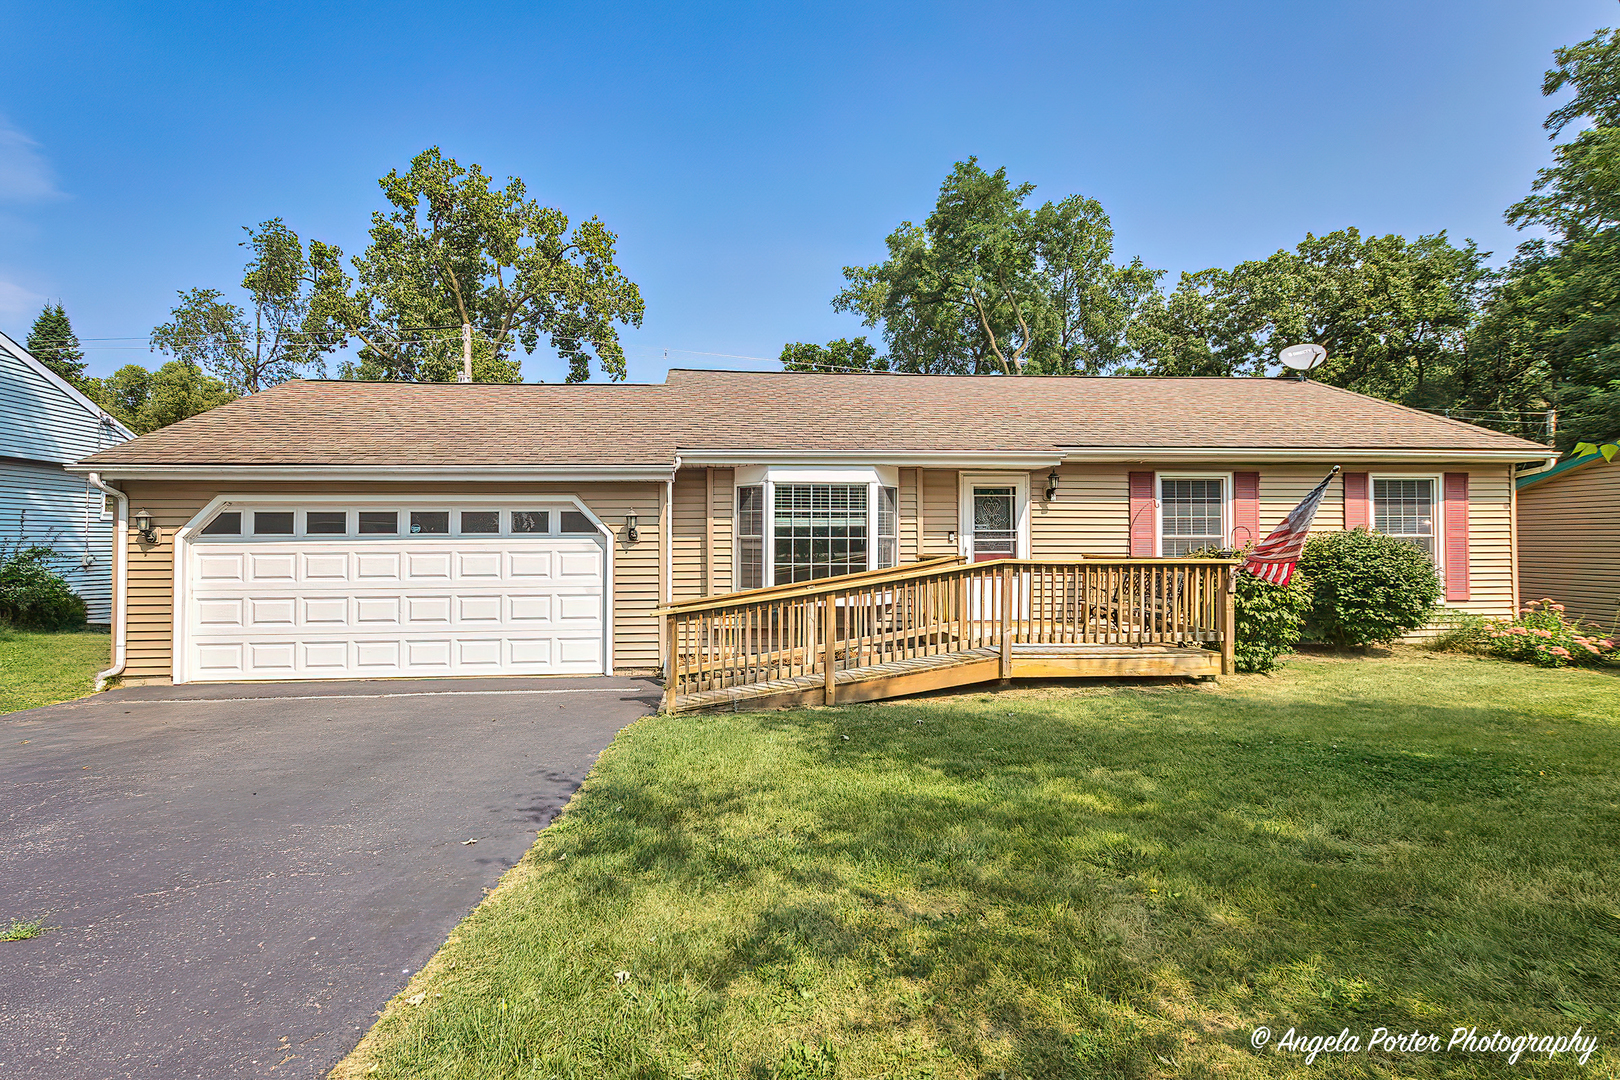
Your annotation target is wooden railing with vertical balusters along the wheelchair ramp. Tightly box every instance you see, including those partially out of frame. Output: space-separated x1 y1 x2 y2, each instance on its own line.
659 557 1234 711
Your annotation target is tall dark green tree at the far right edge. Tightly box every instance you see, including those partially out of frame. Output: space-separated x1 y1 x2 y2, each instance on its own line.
1474 29 1620 449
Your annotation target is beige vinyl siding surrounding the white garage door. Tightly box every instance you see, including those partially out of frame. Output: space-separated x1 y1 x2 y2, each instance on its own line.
122 479 663 682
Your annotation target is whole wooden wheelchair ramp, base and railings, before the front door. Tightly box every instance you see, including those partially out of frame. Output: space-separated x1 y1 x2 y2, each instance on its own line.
661 559 1234 712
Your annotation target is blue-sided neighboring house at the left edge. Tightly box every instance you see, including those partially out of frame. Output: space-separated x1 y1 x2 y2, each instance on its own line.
0 325 134 623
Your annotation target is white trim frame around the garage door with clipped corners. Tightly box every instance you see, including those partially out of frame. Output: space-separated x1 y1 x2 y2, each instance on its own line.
168 492 617 687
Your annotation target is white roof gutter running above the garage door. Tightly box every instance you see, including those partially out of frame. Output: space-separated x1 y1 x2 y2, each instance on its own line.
63 461 676 484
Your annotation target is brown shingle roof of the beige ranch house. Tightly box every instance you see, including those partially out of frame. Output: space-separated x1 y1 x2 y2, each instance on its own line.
86 371 1545 468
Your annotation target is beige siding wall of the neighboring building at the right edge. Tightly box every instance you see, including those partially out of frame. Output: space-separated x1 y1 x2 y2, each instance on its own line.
1518 461 1620 631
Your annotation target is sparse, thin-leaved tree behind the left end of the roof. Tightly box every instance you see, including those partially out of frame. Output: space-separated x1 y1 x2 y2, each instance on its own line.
151 217 332 393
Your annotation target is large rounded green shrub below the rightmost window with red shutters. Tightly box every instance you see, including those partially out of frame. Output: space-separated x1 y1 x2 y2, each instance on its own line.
1299 528 1440 648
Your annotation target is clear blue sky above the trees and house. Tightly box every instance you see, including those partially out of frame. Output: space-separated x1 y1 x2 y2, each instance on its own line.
0 0 1620 381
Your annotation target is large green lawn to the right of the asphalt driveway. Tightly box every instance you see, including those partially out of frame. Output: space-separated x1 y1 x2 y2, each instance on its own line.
335 651 1620 1080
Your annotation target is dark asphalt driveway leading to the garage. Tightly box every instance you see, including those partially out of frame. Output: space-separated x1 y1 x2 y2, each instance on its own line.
0 678 658 1078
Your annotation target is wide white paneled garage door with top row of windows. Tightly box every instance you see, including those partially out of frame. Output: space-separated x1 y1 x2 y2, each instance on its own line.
181 507 608 682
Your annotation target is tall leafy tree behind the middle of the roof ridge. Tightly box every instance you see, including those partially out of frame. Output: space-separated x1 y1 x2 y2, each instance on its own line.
833 157 1158 374
